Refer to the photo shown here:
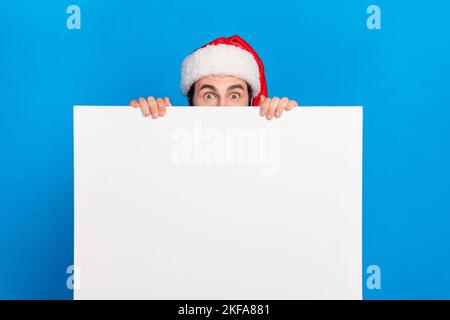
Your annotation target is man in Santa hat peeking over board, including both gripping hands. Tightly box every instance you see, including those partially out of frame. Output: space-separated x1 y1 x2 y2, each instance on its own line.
130 35 298 120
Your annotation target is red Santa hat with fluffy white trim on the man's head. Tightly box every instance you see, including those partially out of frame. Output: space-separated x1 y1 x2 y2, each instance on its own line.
181 35 267 106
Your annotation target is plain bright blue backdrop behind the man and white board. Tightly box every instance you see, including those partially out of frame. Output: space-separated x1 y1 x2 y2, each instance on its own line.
0 0 450 299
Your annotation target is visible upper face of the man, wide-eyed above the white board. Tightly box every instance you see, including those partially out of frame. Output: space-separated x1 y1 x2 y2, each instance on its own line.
192 76 249 106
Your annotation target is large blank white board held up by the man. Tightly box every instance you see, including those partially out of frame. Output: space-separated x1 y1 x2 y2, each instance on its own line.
74 106 362 300
